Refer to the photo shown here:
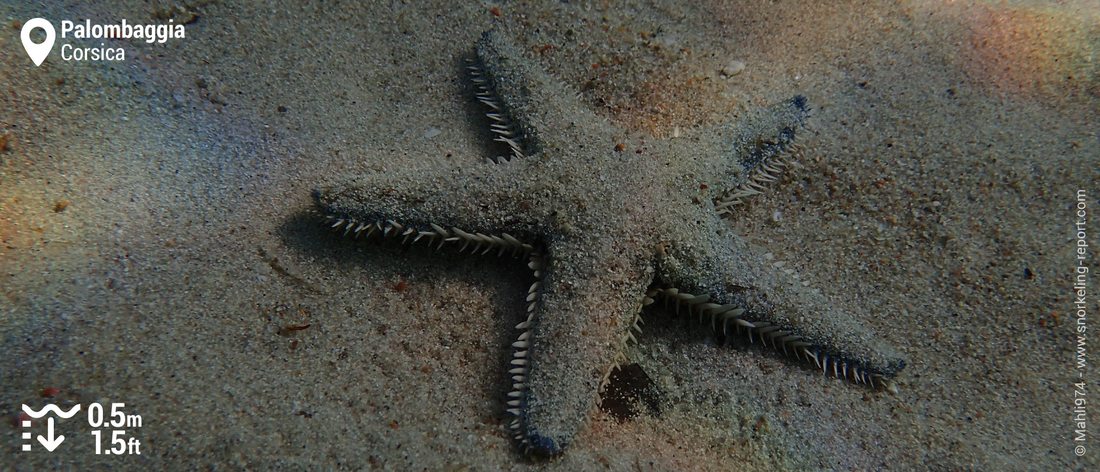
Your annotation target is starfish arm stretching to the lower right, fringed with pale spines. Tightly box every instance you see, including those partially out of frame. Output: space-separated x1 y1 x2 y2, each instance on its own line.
658 224 905 392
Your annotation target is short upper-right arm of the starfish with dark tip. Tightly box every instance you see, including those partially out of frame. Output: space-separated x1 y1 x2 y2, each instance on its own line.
700 96 809 215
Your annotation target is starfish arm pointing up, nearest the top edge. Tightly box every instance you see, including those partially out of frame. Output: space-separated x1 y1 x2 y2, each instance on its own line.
470 30 607 157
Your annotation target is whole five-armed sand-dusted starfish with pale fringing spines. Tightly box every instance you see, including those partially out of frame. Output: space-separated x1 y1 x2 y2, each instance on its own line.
314 30 905 455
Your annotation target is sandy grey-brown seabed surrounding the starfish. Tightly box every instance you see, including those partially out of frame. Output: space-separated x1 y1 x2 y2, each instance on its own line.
0 0 1100 470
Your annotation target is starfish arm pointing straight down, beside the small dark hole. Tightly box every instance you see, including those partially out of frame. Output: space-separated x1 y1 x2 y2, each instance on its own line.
508 238 652 455
